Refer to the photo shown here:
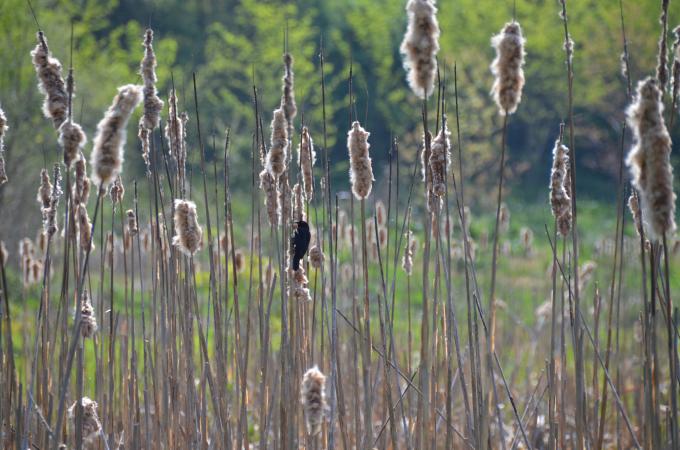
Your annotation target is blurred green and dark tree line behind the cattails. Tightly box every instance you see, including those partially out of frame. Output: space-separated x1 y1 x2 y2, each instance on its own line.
0 0 680 243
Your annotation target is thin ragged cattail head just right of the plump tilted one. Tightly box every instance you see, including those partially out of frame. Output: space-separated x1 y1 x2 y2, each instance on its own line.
138 29 163 171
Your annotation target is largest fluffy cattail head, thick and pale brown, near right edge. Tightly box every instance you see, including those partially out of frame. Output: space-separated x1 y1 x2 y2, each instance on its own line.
626 77 675 240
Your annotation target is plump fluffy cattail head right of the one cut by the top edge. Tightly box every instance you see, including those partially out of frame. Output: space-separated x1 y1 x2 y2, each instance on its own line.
491 21 524 115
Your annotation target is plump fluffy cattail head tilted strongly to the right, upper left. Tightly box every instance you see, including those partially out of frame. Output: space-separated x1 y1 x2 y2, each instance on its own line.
90 84 142 186
